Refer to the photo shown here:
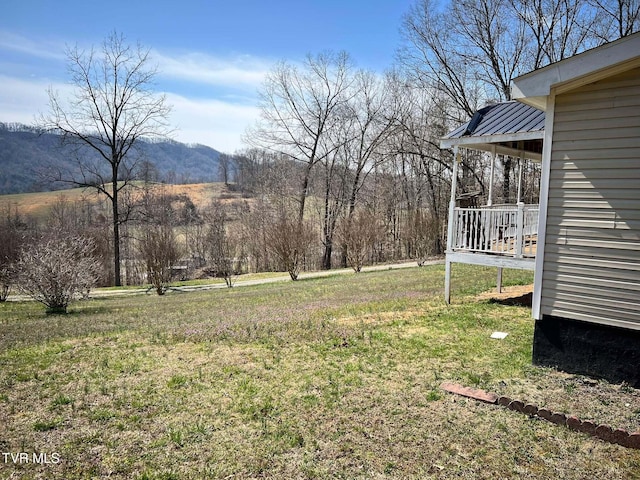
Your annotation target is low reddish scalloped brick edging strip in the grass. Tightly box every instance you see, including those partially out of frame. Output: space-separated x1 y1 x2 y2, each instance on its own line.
440 382 640 449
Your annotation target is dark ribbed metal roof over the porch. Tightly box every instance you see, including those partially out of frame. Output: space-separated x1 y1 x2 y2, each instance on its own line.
440 101 545 160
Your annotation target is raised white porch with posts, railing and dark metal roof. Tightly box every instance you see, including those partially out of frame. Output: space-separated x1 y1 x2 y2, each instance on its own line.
440 102 545 303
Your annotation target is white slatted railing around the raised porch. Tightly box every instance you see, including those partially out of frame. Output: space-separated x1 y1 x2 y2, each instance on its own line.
448 203 540 258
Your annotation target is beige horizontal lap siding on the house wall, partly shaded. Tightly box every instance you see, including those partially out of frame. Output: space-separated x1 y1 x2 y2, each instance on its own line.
540 68 640 329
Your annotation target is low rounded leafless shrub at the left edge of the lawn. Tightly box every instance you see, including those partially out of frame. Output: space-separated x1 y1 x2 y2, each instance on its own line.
18 235 99 313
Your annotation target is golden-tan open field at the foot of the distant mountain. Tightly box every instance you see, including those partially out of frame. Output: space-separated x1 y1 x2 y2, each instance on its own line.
0 182 240 219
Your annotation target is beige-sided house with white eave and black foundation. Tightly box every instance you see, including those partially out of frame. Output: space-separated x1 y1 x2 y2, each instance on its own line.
442 33 640 387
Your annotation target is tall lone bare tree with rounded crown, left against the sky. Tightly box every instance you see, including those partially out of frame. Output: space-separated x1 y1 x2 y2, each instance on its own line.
40 32 170 285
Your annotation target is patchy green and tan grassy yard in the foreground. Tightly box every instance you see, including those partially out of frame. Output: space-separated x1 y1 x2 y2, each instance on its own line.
0 265 640 479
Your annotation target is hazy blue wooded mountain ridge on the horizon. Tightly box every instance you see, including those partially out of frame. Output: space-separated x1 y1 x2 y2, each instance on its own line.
0 122 225 195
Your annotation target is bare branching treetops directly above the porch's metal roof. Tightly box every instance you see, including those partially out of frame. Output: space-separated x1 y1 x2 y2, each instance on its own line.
399 0 604 109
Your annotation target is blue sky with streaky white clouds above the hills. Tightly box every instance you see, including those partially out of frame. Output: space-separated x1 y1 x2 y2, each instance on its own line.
0 0 414 153
